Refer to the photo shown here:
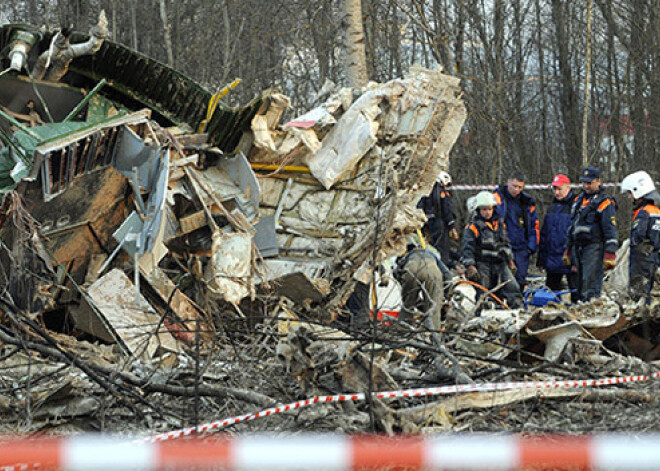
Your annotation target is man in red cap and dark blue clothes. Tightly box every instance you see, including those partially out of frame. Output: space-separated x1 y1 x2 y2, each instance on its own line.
536 174 578 303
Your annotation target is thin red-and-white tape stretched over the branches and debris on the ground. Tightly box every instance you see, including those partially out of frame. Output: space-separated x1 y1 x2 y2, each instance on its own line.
140 372 660 443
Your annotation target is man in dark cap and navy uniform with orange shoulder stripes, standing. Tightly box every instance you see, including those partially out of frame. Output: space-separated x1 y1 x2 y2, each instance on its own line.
563 167 618 301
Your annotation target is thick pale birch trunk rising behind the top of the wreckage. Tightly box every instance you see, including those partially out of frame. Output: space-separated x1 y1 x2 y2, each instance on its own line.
344 0 368 88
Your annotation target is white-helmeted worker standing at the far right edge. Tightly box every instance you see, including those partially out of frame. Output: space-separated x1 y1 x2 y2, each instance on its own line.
621 171 660 304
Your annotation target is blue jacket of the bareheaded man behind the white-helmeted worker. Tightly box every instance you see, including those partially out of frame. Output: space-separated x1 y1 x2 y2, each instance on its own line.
493 185 539 252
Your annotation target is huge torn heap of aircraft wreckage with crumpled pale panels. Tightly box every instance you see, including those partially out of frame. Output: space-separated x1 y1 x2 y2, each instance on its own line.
0 15 466 359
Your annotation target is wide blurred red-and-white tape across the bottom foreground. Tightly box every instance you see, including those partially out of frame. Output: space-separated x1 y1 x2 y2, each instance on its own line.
0 434 660 471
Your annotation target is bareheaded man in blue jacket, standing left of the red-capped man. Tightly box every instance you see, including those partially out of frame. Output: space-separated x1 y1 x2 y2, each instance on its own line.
494 173 539 291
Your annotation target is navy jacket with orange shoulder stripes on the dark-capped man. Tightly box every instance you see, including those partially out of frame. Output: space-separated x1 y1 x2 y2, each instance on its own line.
566 189 619 253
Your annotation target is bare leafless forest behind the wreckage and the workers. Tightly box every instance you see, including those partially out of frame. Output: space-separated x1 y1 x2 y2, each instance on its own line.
0 0 660 206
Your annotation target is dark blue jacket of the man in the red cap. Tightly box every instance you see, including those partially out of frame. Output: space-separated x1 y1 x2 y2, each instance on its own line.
537 191 575 274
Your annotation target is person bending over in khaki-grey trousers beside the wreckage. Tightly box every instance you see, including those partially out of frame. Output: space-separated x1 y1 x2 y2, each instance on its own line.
394 234 447 330
